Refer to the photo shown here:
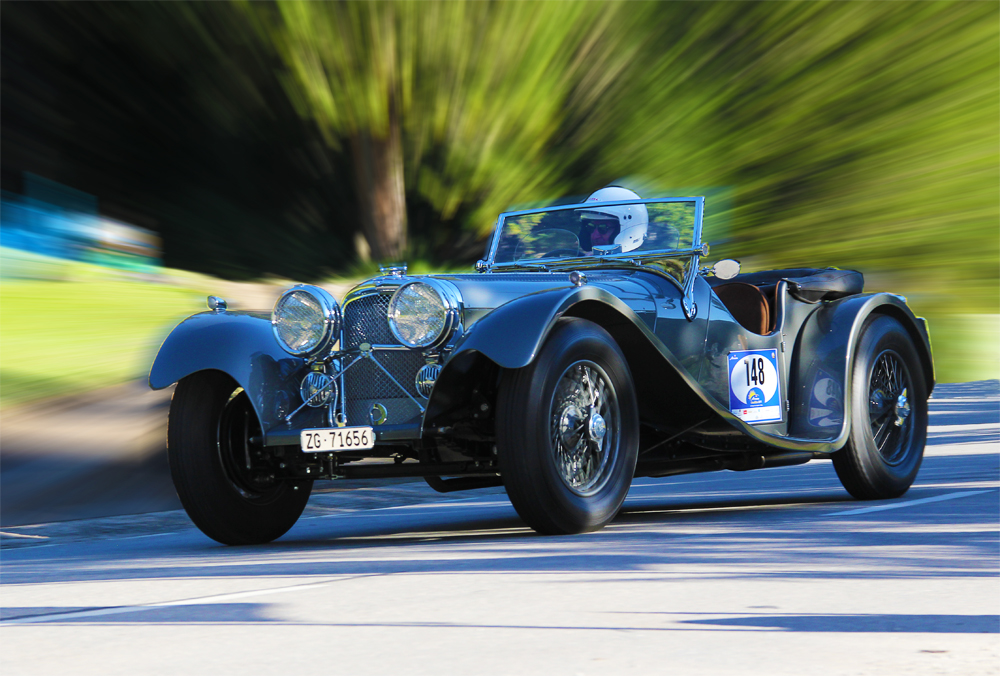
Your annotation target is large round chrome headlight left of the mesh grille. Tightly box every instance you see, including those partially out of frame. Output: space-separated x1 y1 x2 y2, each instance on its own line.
271 284 340 357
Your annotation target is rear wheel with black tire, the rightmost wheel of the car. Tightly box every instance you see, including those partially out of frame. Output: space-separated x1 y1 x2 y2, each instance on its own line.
833 315 927 500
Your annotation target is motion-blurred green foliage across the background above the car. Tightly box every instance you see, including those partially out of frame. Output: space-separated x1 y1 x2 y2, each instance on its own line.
254 2 1000 312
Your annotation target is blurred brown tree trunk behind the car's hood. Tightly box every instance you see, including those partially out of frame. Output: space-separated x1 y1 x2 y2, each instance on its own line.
350 111 406 261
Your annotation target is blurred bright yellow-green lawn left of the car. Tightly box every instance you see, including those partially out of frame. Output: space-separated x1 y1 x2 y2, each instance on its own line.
0 270 205 407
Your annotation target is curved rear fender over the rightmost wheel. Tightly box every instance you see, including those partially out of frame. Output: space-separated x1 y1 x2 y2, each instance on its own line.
789 293 934 450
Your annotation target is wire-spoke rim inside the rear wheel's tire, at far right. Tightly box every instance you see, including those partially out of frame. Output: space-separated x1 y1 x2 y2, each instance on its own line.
868 350 913 465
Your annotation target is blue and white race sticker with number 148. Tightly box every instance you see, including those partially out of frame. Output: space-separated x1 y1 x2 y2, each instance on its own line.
729 350 781 425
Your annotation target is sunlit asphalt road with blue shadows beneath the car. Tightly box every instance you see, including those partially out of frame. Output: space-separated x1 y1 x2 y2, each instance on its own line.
0 381 1000 676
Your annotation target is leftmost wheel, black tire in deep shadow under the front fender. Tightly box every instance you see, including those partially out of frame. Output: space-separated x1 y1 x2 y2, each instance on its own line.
167 371 312 545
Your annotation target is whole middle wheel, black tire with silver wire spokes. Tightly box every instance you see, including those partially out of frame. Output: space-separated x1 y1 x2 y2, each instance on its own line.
497 318 639 535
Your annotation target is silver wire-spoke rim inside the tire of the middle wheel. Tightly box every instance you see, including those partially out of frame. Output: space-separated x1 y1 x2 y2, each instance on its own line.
550 361 621 496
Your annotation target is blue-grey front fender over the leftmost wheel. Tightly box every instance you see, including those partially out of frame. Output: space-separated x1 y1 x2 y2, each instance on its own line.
149 312 305 432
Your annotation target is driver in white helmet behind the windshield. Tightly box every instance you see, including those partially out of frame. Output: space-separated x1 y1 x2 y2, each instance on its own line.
578 186 649 256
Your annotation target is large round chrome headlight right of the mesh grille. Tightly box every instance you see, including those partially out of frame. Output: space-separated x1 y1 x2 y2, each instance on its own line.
389 279 462 347
